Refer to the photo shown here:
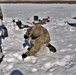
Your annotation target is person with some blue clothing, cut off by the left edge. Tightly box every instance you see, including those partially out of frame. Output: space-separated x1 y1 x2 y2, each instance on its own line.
0 16 8 62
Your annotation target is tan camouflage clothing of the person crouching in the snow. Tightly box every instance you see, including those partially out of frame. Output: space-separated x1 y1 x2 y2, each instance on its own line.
25 25 50 56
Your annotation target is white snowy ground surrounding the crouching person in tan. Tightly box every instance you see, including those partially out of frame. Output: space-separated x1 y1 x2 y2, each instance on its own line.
0 4 76 75
